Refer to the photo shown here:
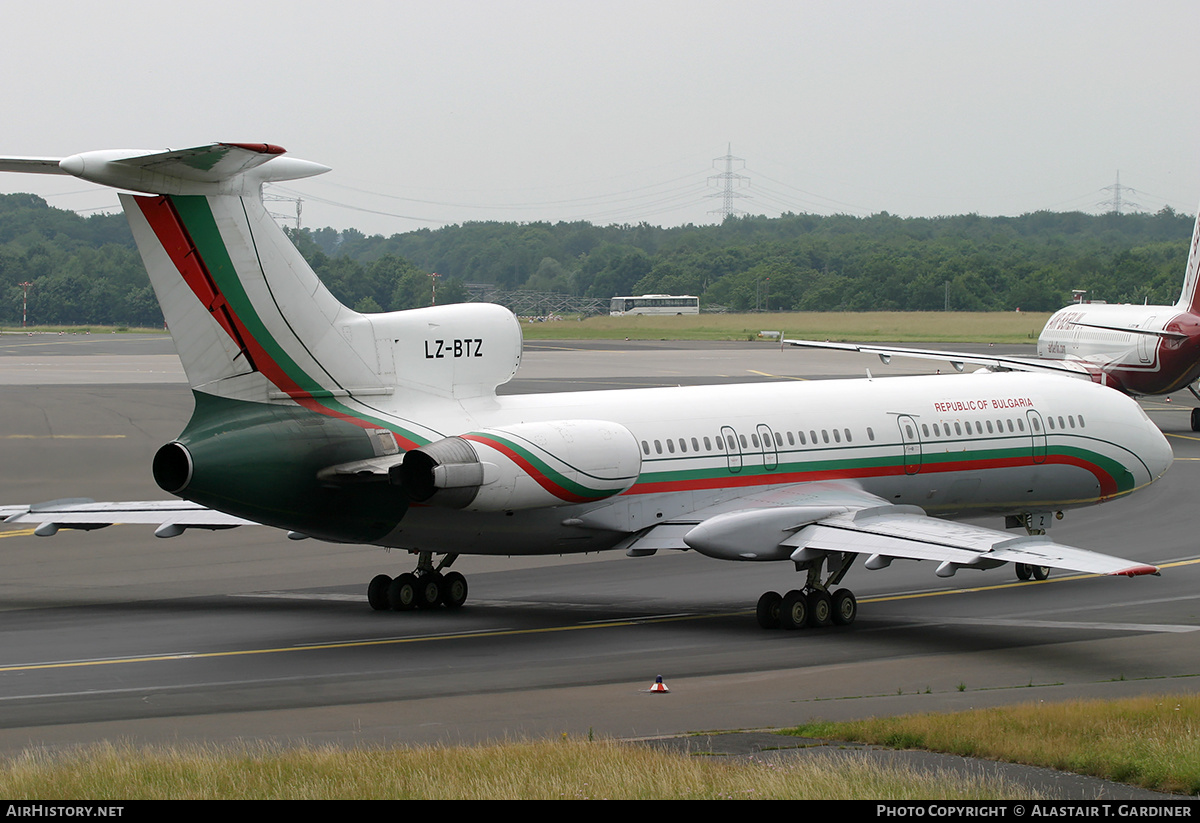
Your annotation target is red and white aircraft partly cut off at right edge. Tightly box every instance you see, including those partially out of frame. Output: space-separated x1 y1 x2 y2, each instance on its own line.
784 203 1200 432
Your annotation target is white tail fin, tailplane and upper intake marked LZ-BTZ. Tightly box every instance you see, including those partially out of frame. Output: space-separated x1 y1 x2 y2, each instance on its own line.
0 143 521 426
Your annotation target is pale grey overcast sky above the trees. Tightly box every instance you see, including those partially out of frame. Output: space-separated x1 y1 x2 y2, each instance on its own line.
0 0 1200 234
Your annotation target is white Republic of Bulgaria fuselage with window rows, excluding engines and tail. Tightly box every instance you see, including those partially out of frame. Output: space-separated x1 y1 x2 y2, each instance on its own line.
382 373 1171 554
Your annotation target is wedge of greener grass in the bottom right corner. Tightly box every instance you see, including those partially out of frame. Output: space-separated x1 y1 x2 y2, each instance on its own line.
791 695 1200 794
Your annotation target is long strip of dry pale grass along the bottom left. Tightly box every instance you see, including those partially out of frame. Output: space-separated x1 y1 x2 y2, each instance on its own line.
0 740 1030 800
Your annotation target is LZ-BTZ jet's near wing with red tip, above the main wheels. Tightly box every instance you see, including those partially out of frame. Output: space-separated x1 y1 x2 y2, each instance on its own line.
620 481 1158 577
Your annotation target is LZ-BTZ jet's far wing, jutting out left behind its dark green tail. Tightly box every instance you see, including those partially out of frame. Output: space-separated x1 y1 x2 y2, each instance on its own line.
0 498 258 537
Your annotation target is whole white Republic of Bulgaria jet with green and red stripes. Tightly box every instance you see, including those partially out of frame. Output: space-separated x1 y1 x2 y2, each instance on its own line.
0 143 1172 629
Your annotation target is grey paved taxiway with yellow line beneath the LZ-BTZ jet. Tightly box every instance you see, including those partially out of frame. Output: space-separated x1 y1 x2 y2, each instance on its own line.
0 336 1200 801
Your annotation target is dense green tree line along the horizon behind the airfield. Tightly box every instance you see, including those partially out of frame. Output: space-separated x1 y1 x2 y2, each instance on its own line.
0 194 1192 326
